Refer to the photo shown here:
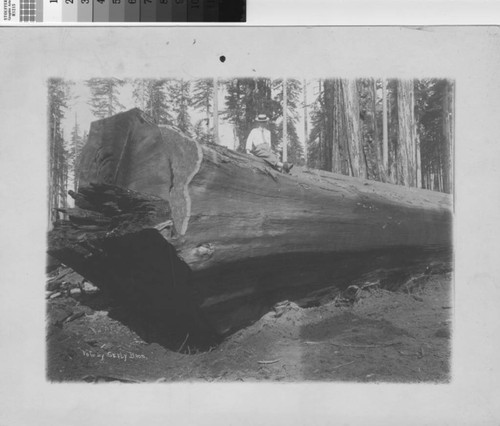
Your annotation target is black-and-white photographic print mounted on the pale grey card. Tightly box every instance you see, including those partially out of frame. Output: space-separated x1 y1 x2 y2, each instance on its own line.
46 77 455 382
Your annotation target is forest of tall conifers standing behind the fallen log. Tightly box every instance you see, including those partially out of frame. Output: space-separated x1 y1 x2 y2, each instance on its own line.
48 78 455 222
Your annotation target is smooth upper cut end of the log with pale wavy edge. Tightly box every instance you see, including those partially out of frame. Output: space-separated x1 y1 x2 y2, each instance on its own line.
80 108 203 235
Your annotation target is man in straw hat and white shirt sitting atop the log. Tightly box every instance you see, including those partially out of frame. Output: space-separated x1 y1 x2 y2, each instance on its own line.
246 114 293 173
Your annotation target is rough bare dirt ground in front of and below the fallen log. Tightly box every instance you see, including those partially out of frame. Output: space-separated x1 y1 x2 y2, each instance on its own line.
47 274 452 383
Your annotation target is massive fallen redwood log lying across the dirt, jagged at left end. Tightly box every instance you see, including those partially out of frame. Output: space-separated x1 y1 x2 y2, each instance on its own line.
49 109 452 342
